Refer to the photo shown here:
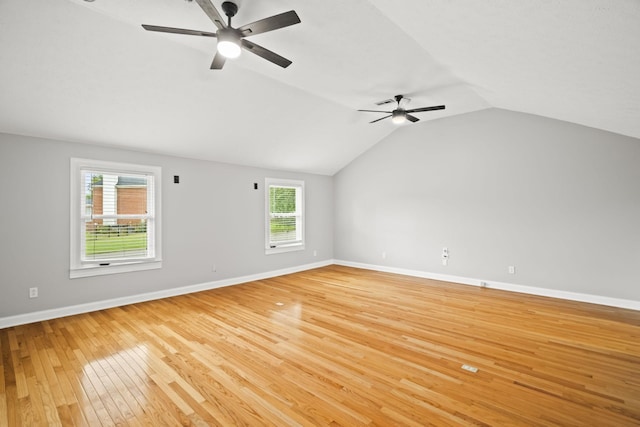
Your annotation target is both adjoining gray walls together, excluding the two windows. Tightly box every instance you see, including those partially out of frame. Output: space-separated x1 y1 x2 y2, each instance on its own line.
0 109 640 317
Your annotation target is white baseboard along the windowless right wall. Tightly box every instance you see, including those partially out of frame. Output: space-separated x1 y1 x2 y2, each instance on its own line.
334 260 640 310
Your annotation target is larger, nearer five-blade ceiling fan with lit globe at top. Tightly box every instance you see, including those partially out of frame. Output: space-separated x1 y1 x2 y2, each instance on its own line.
142 0 300 70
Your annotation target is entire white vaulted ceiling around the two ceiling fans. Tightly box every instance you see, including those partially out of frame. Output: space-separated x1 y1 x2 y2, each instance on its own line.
0 0 640 175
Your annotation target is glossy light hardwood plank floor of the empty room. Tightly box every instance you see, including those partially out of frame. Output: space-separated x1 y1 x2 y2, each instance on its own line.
0 266 640 427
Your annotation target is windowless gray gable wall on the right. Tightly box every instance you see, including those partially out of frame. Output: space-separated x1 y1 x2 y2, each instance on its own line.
334 109 640 301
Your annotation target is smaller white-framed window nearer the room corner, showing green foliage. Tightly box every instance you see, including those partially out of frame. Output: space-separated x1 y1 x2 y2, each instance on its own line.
265 178 304 254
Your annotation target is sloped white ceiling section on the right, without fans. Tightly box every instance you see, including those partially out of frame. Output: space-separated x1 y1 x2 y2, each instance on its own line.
372 0 640 138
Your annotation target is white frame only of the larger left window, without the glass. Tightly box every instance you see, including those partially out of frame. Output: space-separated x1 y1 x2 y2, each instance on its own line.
69 157 162 279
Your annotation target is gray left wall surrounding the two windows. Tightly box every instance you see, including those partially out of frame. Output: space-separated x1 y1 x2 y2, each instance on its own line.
0 134 333 317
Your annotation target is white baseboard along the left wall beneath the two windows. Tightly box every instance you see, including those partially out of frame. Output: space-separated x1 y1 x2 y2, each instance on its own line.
0 260 333 328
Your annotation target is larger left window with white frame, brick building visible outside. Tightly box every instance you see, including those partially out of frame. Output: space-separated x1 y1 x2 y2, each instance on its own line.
70 158 162 278
